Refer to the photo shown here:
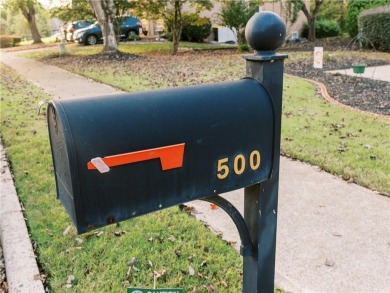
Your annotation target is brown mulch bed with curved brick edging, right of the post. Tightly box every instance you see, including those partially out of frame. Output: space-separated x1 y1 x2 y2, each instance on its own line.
279 38 390 116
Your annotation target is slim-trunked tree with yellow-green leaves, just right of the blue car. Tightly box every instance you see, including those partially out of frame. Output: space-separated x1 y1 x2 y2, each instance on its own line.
137 0 213 55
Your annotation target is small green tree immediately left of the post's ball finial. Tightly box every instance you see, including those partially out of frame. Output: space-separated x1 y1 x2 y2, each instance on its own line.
221 0 262 45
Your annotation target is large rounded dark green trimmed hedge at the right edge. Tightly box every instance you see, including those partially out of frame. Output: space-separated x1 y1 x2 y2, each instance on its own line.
359 5 390 51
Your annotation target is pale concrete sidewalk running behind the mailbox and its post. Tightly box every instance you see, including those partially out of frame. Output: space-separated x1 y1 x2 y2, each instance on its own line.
1 49 390 292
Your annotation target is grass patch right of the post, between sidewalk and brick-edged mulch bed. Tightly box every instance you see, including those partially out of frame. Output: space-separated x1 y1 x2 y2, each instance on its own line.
282 78 390 190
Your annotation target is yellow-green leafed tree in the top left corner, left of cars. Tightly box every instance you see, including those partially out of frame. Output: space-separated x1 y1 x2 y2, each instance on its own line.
3 0 42 44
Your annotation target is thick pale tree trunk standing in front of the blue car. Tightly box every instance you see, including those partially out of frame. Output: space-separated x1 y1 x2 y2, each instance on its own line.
88 0 118 53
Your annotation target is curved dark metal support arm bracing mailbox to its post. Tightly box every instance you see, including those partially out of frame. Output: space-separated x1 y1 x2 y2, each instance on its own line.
202 195 255 257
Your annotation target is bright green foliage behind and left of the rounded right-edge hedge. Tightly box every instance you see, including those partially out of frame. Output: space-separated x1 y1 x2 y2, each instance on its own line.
345 0 390 38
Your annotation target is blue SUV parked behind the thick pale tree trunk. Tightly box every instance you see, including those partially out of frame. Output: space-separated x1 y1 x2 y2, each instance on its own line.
74 16 142 45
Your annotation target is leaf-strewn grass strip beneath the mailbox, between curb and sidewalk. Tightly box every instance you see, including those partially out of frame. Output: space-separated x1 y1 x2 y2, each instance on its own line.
0 65 242 292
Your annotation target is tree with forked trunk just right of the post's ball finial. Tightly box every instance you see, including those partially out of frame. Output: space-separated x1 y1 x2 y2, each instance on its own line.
286 0 325 41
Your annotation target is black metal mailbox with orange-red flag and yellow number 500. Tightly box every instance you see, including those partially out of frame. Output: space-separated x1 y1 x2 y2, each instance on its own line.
47 78 275 233
